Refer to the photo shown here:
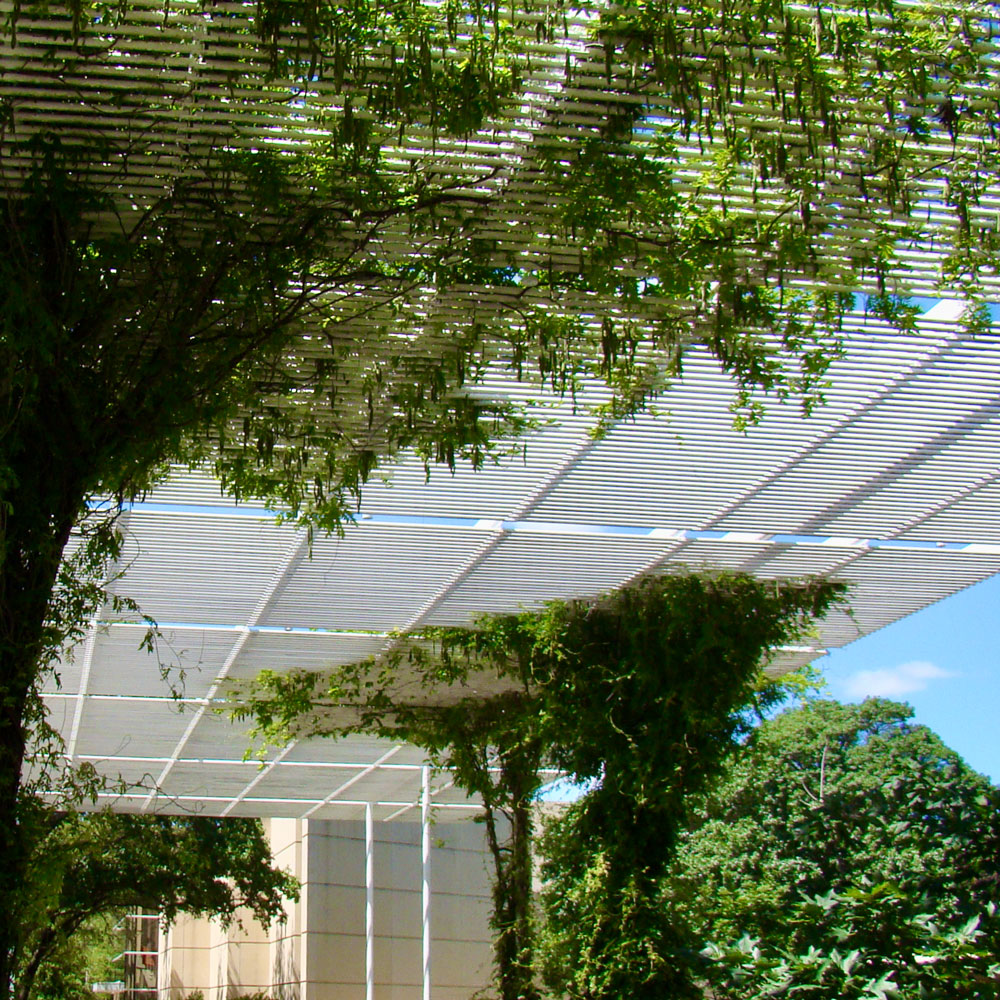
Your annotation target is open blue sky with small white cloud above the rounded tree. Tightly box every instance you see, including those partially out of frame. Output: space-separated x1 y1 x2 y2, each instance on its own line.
816 576 1000 784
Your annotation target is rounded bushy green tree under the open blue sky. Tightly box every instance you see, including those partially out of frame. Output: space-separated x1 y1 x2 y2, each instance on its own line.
664 699 1000 997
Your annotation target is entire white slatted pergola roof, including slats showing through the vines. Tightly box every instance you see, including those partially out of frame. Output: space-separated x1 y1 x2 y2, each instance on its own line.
7 0 1000 819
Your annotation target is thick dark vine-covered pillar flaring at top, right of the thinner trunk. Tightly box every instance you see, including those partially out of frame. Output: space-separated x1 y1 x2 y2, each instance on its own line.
542 574 844 1000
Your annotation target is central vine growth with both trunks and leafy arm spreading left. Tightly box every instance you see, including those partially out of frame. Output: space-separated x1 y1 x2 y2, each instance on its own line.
235 573 842 1000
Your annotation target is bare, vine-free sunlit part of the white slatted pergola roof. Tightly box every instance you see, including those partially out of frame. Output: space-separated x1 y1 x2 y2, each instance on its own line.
41 302 1000 819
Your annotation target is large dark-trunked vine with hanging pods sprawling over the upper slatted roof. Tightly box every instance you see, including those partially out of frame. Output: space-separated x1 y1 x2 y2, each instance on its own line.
0 0 1000 989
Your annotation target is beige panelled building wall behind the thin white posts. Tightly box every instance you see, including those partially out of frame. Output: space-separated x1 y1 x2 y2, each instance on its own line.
160 820 491 1000
